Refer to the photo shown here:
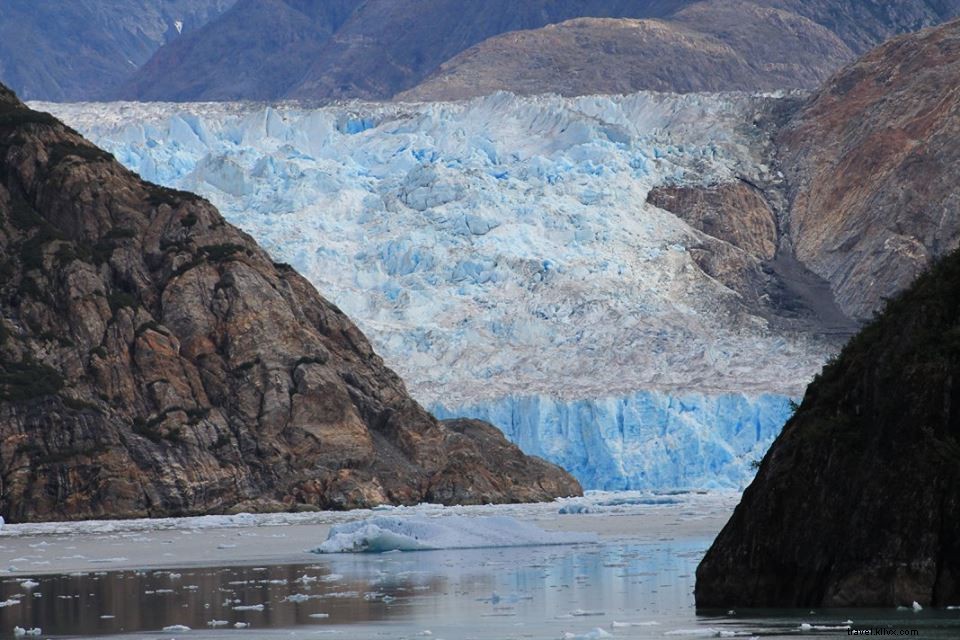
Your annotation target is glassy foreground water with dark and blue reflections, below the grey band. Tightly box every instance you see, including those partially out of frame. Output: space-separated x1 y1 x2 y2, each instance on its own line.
0 540 960 640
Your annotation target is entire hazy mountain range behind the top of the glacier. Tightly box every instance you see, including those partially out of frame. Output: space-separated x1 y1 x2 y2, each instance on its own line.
7 0 960 101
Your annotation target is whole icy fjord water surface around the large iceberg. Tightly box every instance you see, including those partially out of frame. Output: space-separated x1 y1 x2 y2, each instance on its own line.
0 493 960 640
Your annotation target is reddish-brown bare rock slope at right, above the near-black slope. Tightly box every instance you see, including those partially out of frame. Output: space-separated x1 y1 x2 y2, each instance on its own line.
778 22 960 320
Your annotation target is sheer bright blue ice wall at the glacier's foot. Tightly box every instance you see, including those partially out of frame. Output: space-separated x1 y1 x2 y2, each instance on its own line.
432 391 791 490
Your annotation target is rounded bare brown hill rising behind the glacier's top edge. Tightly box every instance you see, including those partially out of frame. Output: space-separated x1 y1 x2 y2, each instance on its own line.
397 1 853 100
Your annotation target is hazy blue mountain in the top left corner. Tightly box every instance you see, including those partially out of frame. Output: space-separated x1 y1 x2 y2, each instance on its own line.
0 0 235 100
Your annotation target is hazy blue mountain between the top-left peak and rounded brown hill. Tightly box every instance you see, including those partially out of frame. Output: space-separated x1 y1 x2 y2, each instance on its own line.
117 0 687 100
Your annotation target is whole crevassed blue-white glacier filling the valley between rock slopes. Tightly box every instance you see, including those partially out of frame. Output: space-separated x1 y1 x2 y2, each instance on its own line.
32 93 832 489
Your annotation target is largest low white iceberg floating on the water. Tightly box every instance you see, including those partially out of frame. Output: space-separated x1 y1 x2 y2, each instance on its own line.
313 516 597 553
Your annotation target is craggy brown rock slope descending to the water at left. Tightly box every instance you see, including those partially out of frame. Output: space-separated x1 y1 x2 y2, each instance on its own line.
0 88 580 521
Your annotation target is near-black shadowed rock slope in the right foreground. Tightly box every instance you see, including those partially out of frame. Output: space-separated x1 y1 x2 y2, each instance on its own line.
696 246 960 608
